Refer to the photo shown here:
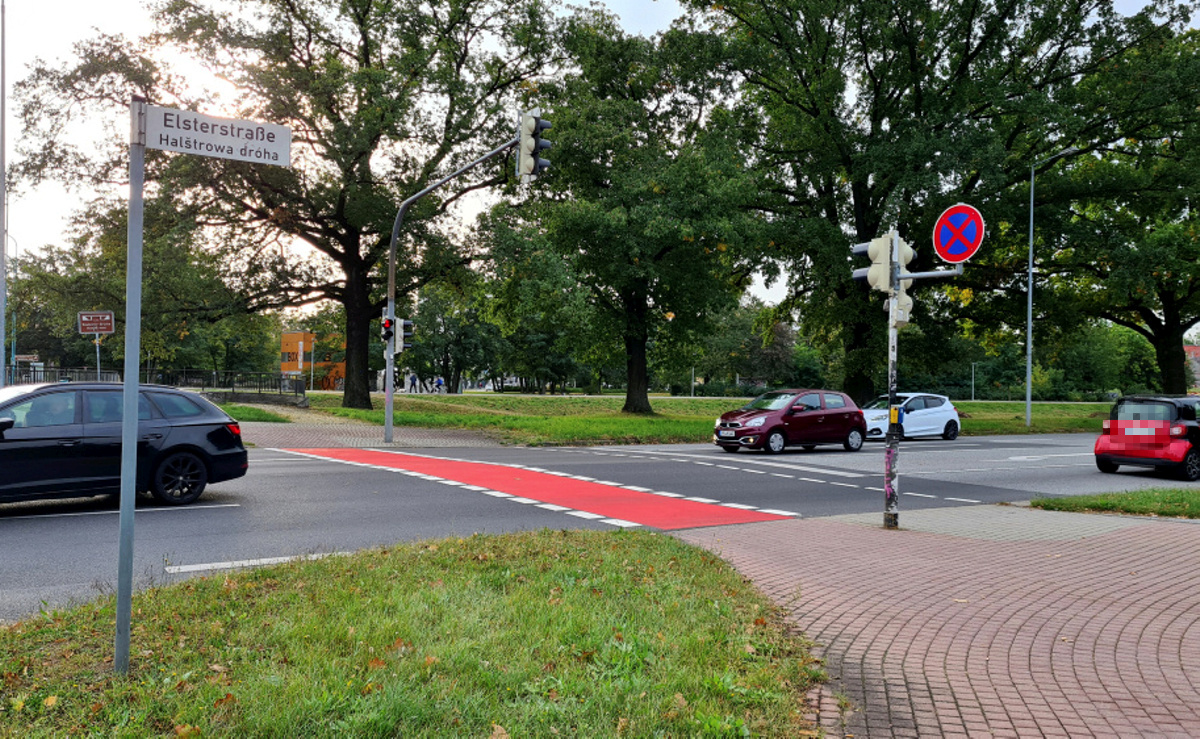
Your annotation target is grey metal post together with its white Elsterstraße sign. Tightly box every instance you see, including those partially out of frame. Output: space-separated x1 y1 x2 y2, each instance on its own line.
112 96 292 674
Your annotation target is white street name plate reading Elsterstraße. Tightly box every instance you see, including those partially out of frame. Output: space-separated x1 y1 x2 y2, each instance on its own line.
145 106 292 167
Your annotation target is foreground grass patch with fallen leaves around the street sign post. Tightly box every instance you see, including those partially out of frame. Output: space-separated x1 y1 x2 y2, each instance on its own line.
0 530 824 737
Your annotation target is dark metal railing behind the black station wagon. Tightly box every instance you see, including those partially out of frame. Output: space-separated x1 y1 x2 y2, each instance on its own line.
10 367 305 397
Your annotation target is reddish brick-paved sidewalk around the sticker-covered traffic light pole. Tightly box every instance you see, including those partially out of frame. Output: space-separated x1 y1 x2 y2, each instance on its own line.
676 506 1200 738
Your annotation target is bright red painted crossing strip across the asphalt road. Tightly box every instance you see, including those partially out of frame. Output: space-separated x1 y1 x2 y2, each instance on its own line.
284 449 788 530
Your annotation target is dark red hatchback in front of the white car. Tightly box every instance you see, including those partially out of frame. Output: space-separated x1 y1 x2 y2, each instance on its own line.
713 390 866 453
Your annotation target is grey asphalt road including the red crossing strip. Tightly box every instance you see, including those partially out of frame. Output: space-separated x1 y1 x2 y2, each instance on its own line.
0 434 1171 620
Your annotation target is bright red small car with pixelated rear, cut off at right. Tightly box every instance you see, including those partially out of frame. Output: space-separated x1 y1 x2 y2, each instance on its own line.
1094 396 1200 480
